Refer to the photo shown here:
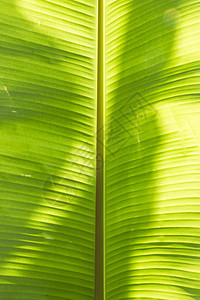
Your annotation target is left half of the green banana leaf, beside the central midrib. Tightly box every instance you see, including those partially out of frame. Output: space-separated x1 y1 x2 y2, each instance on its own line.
0 0 96 300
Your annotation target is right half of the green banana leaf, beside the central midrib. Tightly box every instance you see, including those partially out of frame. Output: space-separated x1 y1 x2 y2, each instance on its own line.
105 0 200 300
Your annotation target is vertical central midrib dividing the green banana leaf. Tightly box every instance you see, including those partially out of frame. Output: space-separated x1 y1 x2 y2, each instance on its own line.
95 0 104 300
